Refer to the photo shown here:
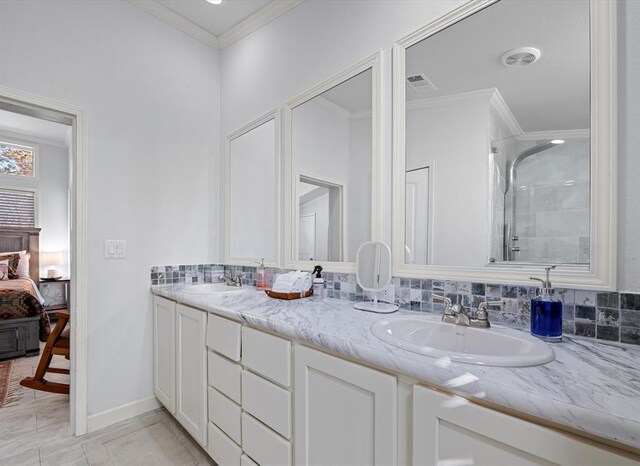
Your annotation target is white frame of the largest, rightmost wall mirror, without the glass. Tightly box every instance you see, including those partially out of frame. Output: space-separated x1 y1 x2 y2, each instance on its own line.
392 0 617 290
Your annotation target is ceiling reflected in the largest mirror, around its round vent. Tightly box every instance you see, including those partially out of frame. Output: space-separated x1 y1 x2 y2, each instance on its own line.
406 0 590 132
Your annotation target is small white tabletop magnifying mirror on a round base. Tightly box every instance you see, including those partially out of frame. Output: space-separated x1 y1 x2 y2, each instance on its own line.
353 241 398 314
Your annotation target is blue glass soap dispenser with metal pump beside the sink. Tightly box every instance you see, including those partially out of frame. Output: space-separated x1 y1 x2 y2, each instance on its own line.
529 265 562 342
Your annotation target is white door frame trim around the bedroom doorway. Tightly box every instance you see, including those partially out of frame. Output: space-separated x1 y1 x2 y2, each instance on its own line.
0 86 88 435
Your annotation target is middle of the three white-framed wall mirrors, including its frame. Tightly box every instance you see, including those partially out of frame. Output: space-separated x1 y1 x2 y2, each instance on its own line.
284 53 380 272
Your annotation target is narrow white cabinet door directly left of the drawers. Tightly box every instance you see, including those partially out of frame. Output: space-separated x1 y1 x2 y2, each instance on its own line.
176 304 207 446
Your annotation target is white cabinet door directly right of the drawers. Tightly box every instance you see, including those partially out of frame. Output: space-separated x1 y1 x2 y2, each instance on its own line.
294 345 397 466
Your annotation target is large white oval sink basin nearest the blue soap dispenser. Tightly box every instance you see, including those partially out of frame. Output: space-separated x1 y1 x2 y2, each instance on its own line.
371 316 555 367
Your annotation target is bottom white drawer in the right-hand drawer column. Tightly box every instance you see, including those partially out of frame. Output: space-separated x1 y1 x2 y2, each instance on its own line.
242 413 291 466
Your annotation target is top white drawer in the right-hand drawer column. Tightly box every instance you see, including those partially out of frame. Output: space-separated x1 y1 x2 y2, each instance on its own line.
242 327 291 387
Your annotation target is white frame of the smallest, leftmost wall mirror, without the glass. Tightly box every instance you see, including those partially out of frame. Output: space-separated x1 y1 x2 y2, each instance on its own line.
224 108 282 268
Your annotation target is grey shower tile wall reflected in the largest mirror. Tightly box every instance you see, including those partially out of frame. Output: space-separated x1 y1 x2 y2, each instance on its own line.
506 139 590 263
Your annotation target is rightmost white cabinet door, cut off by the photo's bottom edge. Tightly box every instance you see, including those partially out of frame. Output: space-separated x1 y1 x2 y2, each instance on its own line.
413 386 640 466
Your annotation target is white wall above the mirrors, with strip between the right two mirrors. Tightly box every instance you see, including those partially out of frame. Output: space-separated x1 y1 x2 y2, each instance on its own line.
220 0 464 258
